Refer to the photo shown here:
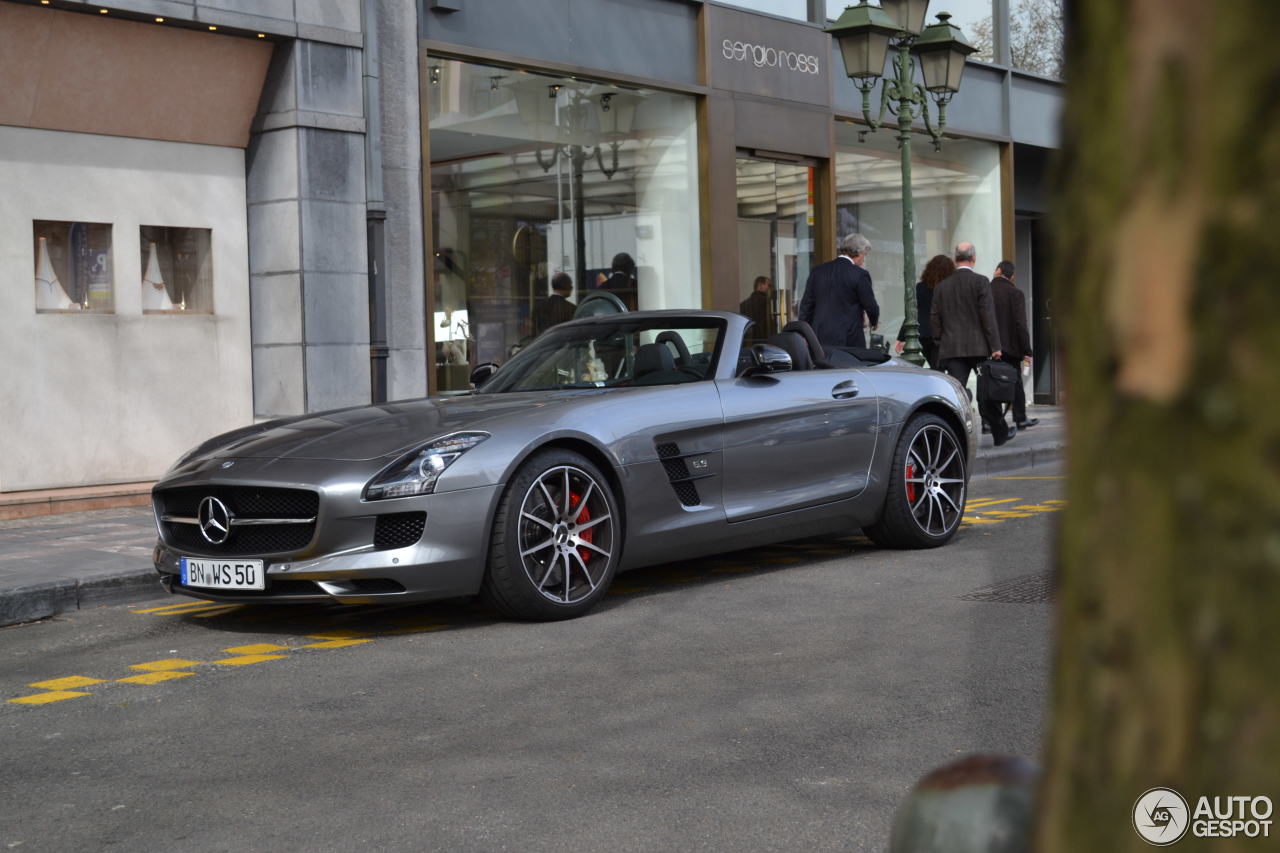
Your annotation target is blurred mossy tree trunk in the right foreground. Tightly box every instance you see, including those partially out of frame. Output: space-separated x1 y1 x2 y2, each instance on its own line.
1037 0 1280 853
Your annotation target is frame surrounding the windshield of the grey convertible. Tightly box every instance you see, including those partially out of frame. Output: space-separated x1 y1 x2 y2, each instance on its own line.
475 314 730 394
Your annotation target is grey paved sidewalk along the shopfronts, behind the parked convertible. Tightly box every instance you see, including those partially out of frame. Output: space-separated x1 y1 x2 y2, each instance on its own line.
0 406 1066 625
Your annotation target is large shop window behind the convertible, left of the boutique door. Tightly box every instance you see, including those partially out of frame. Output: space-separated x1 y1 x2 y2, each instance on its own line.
426 60 701 391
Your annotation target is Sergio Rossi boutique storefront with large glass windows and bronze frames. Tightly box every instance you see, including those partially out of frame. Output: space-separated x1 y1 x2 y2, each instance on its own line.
420 0 1029 393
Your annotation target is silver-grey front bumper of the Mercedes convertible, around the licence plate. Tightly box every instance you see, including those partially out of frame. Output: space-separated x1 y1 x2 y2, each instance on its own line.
154 485 502 605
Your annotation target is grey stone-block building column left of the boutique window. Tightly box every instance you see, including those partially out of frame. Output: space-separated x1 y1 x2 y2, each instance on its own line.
246 40 370 419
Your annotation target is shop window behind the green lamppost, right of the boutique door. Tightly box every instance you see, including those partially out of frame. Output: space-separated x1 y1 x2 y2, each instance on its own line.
836 122 1002 341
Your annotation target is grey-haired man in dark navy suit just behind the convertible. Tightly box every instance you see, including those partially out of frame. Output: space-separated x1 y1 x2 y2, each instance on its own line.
800 234 879 347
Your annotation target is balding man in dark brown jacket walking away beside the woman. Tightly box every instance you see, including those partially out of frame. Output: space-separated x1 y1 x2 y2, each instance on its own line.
931 236 1018 438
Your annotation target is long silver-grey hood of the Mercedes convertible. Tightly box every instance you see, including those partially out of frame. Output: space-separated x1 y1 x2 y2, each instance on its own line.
196 392 590 461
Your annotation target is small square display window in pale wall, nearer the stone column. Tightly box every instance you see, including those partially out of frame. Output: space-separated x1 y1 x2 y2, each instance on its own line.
138 225 214 314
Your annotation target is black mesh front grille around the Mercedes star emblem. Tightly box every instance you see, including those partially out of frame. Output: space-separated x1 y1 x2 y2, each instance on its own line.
155 485 320 556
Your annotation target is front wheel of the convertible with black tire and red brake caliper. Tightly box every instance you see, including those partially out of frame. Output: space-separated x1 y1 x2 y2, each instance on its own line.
481 448 622 621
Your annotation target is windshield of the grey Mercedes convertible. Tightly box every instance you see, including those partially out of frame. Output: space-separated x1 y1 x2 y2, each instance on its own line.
477 318 724 394
